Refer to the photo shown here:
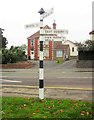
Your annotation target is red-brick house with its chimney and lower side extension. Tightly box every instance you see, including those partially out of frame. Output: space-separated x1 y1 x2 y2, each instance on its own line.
27 21 69 60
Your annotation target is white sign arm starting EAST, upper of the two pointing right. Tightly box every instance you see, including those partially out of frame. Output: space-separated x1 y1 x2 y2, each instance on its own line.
40 29 68 34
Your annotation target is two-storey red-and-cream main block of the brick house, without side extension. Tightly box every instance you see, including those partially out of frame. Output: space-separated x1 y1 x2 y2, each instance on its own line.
27 25 52 60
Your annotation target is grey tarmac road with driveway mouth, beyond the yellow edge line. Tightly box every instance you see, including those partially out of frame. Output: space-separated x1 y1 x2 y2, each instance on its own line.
2 60 93 89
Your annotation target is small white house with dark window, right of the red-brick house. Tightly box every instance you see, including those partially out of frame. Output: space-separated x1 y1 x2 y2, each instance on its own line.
62 40 78 57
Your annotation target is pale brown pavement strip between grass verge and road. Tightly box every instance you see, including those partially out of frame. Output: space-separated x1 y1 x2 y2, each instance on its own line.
0 85 94 101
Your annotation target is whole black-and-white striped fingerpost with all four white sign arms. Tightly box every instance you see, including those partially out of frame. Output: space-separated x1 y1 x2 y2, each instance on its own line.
25 8 68 99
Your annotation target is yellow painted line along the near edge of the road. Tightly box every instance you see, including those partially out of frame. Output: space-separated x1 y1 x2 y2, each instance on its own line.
0 84 94 91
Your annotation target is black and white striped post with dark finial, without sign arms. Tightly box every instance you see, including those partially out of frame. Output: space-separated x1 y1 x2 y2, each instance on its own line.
39 8 45 99
